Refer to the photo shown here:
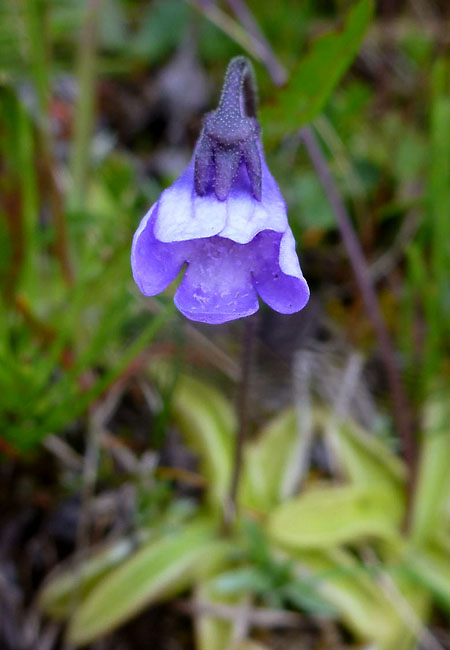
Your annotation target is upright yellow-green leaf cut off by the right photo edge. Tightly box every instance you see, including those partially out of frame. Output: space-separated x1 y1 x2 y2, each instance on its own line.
411 394 450 543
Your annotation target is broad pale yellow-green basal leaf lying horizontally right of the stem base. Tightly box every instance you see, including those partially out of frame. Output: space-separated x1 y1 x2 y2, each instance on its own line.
268 485 403 549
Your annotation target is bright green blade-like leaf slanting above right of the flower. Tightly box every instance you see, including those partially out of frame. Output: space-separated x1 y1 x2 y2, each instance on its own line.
261 0 374 136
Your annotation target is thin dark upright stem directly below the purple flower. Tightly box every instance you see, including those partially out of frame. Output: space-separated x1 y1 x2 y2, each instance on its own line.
224 316 256 532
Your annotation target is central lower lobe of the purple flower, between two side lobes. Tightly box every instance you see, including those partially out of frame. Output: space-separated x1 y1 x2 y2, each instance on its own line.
174 237 259 324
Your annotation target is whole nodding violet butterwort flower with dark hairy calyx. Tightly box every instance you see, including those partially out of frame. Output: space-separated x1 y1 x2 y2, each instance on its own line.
131 57 309 324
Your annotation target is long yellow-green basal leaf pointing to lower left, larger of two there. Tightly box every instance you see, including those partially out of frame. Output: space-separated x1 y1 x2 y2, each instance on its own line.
68 520 224 645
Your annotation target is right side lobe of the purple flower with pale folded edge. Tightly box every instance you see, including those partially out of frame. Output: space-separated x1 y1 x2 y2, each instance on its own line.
253 228 309 314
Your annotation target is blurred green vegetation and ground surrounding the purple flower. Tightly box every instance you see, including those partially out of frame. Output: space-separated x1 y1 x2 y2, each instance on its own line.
0 0 450 650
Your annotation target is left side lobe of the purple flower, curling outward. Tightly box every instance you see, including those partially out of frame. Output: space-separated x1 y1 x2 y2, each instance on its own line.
131 203 190 296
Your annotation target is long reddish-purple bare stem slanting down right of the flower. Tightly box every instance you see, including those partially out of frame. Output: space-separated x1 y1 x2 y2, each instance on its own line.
300 128 417 516
